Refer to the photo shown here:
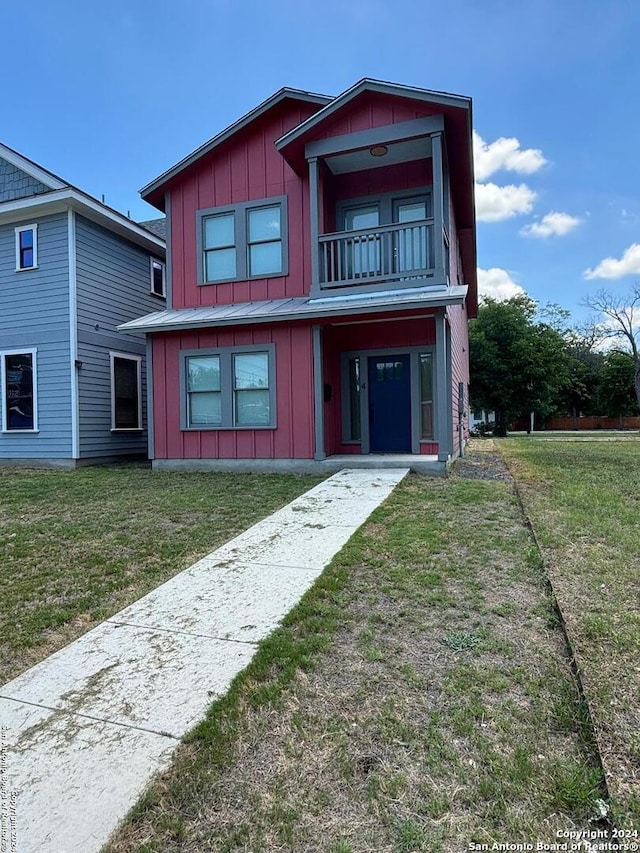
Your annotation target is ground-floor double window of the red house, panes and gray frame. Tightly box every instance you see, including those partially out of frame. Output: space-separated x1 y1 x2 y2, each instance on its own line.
181 344 276 429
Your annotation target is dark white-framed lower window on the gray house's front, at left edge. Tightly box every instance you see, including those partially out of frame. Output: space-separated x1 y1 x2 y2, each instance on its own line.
0 349 38 432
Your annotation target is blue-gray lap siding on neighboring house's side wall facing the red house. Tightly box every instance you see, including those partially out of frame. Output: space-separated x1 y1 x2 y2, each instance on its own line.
76 216 164 458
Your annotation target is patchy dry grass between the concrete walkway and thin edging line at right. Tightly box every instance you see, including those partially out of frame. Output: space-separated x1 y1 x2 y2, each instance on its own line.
106 475 601 853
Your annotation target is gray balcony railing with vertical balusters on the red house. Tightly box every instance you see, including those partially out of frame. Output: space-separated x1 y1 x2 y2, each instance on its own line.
318 218 436 289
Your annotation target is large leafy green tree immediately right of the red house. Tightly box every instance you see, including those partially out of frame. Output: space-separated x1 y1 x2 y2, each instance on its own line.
469 296 569 435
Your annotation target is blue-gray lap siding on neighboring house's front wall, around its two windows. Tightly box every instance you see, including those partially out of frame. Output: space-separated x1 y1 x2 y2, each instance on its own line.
0 213 72 460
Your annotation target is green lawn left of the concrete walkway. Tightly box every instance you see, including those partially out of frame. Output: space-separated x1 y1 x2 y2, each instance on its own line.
0 465 317 683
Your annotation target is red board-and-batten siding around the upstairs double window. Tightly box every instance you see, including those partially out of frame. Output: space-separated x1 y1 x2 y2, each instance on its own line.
170 101 314 308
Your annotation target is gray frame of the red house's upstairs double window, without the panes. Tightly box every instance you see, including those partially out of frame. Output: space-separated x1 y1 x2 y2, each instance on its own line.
196 195 289 286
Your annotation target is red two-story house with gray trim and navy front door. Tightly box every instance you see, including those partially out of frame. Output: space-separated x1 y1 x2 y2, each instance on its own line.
121 79 477 470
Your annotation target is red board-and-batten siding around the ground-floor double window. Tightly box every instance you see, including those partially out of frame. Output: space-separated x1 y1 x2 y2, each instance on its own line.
153 323 314 459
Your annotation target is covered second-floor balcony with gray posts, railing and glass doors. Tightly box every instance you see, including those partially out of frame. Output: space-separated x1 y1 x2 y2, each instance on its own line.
306 116 451 296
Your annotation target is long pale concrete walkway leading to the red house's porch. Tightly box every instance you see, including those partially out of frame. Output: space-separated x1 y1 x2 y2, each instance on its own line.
0 468 407 853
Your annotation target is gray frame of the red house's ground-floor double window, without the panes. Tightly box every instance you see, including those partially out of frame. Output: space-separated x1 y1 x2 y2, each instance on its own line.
180 343 278 432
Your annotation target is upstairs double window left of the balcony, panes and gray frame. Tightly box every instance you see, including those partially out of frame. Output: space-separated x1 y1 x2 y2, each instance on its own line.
198 196 287 284
